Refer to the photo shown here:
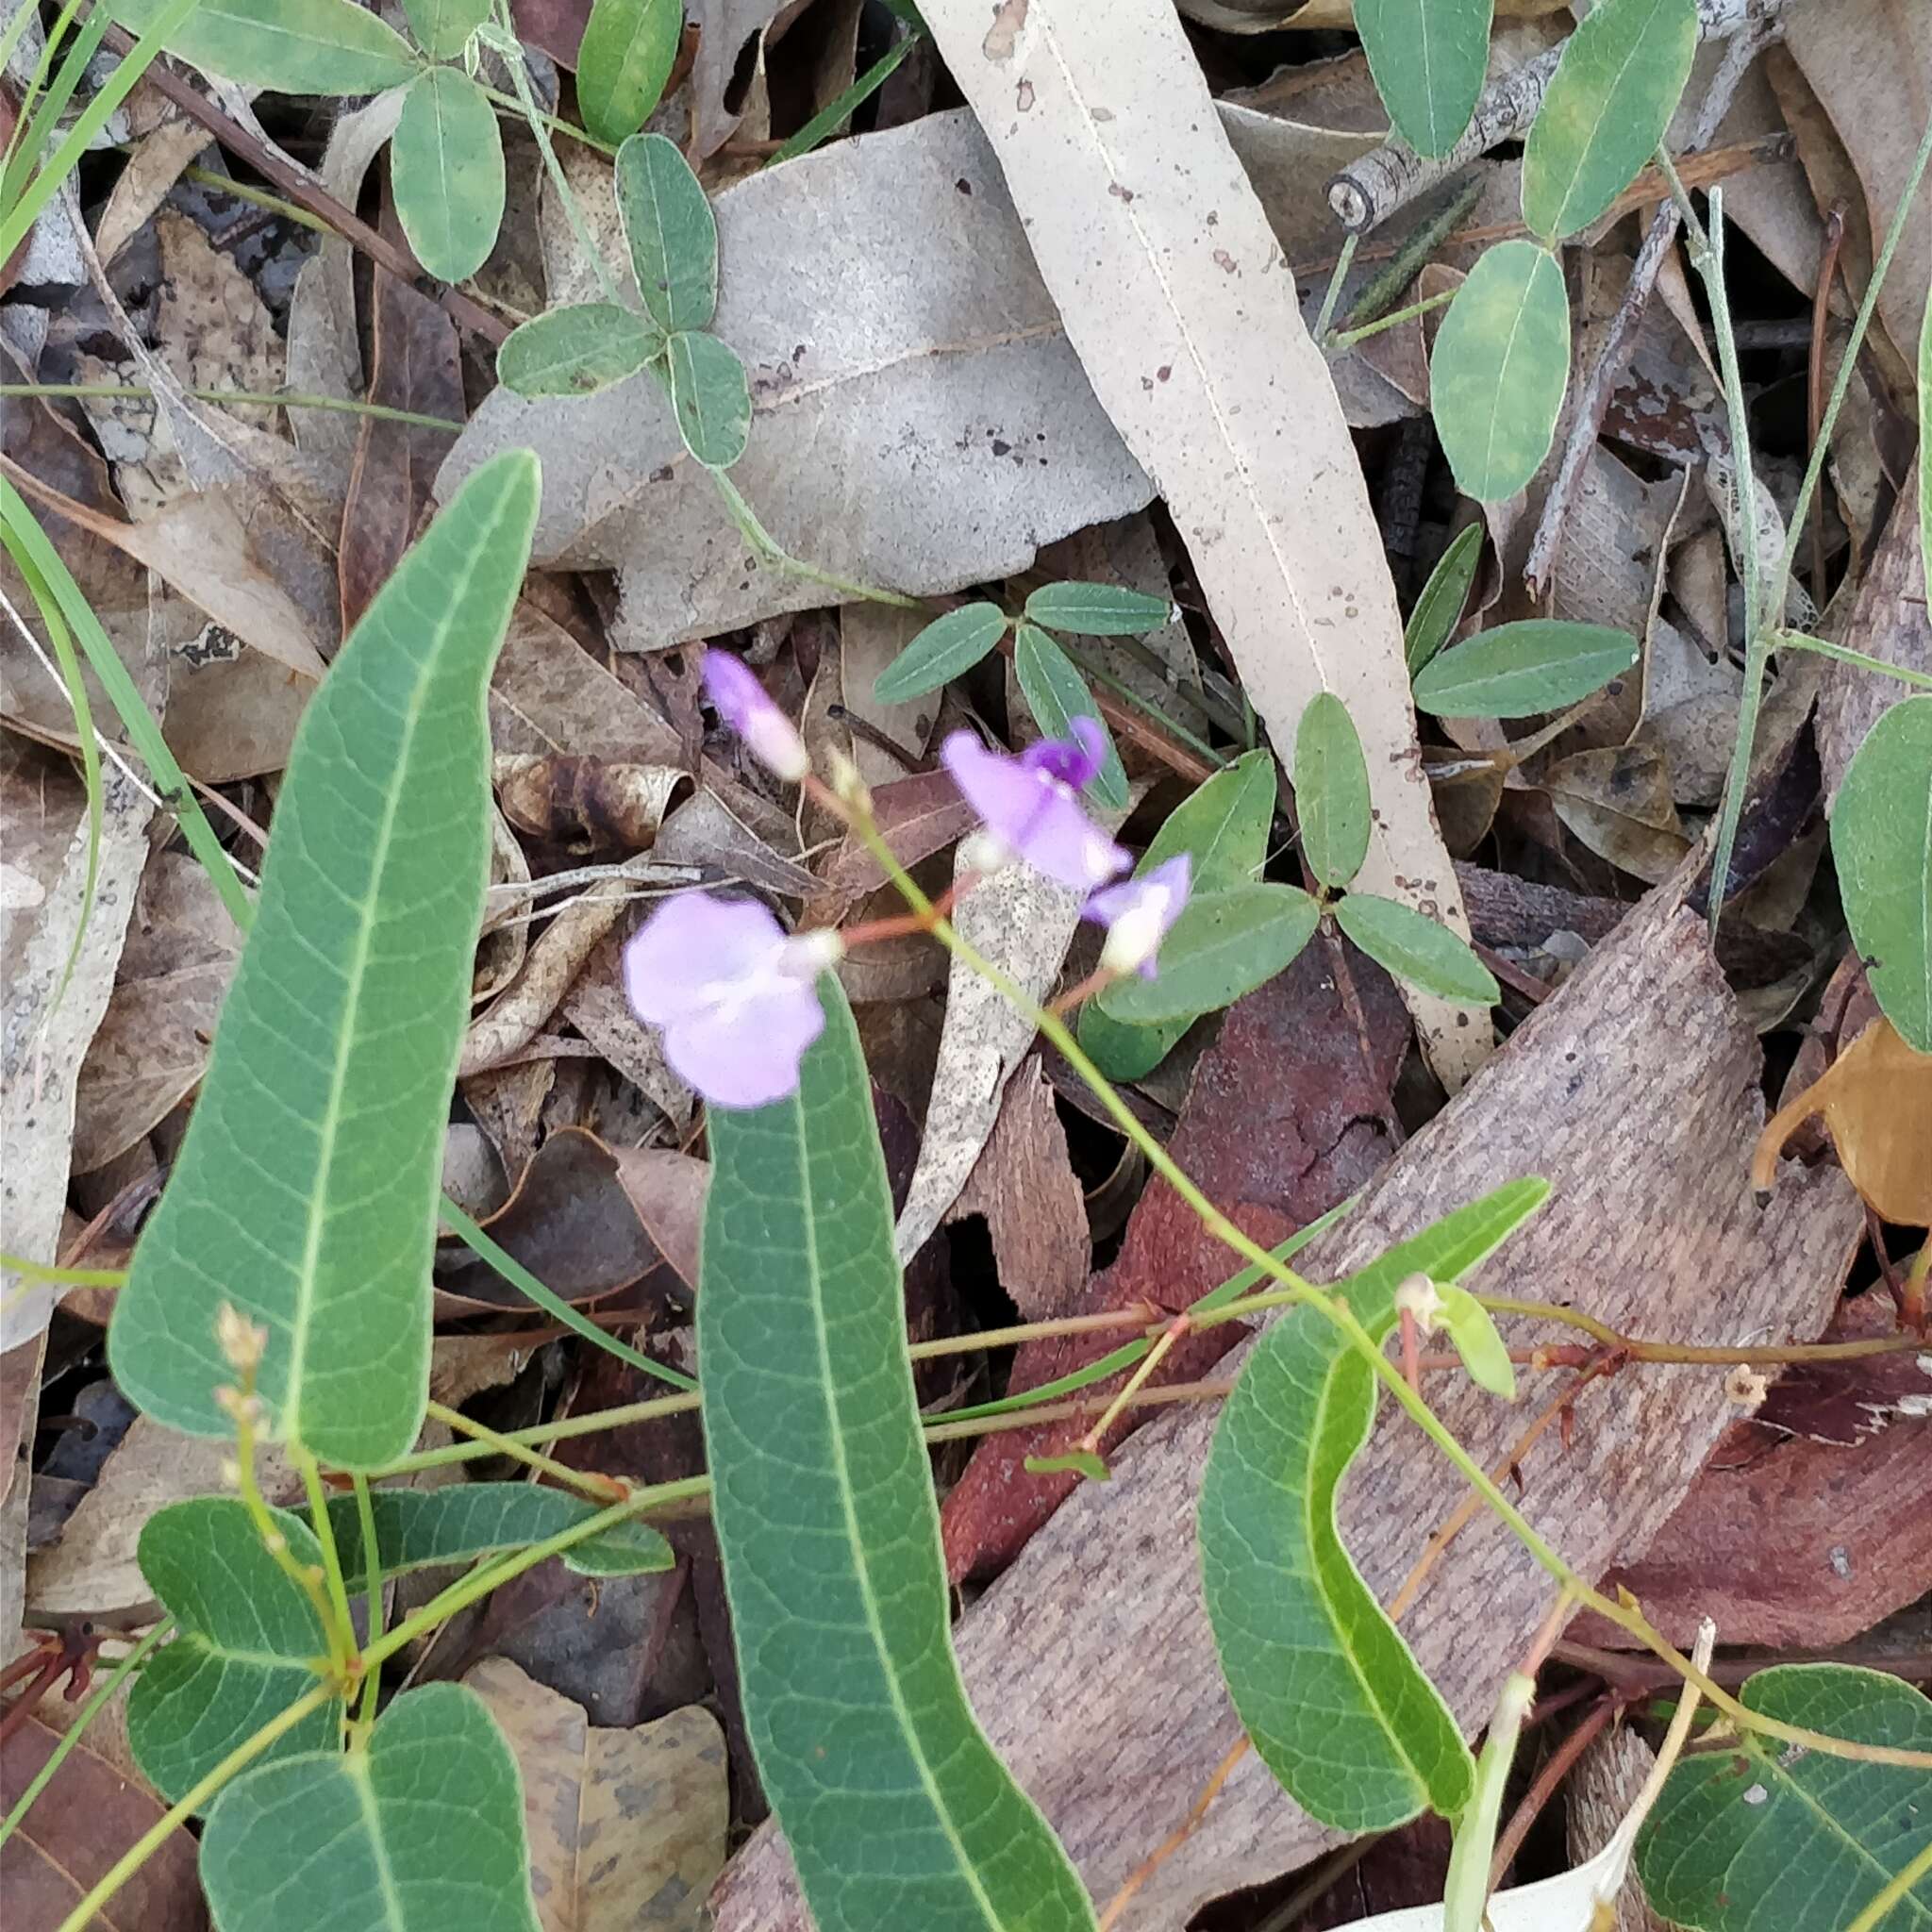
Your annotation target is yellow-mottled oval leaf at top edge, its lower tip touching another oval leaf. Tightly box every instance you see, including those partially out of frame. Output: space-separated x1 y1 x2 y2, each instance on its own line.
1523 0 1698 247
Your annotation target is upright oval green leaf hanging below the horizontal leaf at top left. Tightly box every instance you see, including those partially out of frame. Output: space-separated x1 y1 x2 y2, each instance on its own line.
391 68 505 282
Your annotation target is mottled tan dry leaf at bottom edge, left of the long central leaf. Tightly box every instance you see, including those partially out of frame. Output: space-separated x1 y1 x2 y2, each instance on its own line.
464 1657 730 1932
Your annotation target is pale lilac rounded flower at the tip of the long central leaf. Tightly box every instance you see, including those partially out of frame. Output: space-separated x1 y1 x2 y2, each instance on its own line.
625 892 842 1108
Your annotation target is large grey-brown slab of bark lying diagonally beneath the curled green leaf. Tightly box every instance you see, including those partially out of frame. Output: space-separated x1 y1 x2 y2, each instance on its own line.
713 877 1862 1932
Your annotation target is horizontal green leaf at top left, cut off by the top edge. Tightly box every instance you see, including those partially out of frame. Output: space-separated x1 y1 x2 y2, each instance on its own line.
112 0 424 94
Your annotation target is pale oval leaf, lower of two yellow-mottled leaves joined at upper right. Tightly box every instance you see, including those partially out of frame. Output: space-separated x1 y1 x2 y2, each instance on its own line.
1430 242 1569 502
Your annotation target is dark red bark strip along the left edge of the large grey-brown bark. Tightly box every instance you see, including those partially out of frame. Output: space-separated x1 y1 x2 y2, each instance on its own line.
939 941 1408 1582
